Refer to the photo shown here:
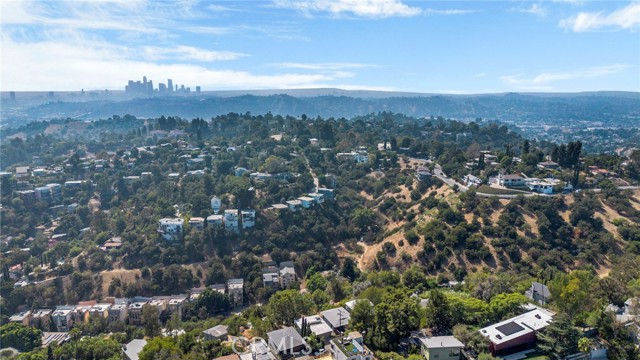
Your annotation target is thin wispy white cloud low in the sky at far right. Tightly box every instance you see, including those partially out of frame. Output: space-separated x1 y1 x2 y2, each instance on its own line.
499 64 630 91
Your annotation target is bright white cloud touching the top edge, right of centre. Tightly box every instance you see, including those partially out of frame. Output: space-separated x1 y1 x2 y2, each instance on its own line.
274 0 422 18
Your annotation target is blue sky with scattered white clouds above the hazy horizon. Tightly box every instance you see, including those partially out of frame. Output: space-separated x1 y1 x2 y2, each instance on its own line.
0 0 640 93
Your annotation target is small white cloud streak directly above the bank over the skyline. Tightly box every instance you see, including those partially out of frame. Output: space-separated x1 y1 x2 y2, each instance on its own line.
142 45 248 62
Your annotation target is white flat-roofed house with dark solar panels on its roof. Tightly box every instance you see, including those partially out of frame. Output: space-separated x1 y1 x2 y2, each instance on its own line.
479 308 553 355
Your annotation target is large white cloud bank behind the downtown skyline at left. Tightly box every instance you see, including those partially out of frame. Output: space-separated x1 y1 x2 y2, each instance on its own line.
1 34 372 91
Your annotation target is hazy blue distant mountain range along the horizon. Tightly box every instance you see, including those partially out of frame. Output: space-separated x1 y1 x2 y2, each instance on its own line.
0 89 640 126
